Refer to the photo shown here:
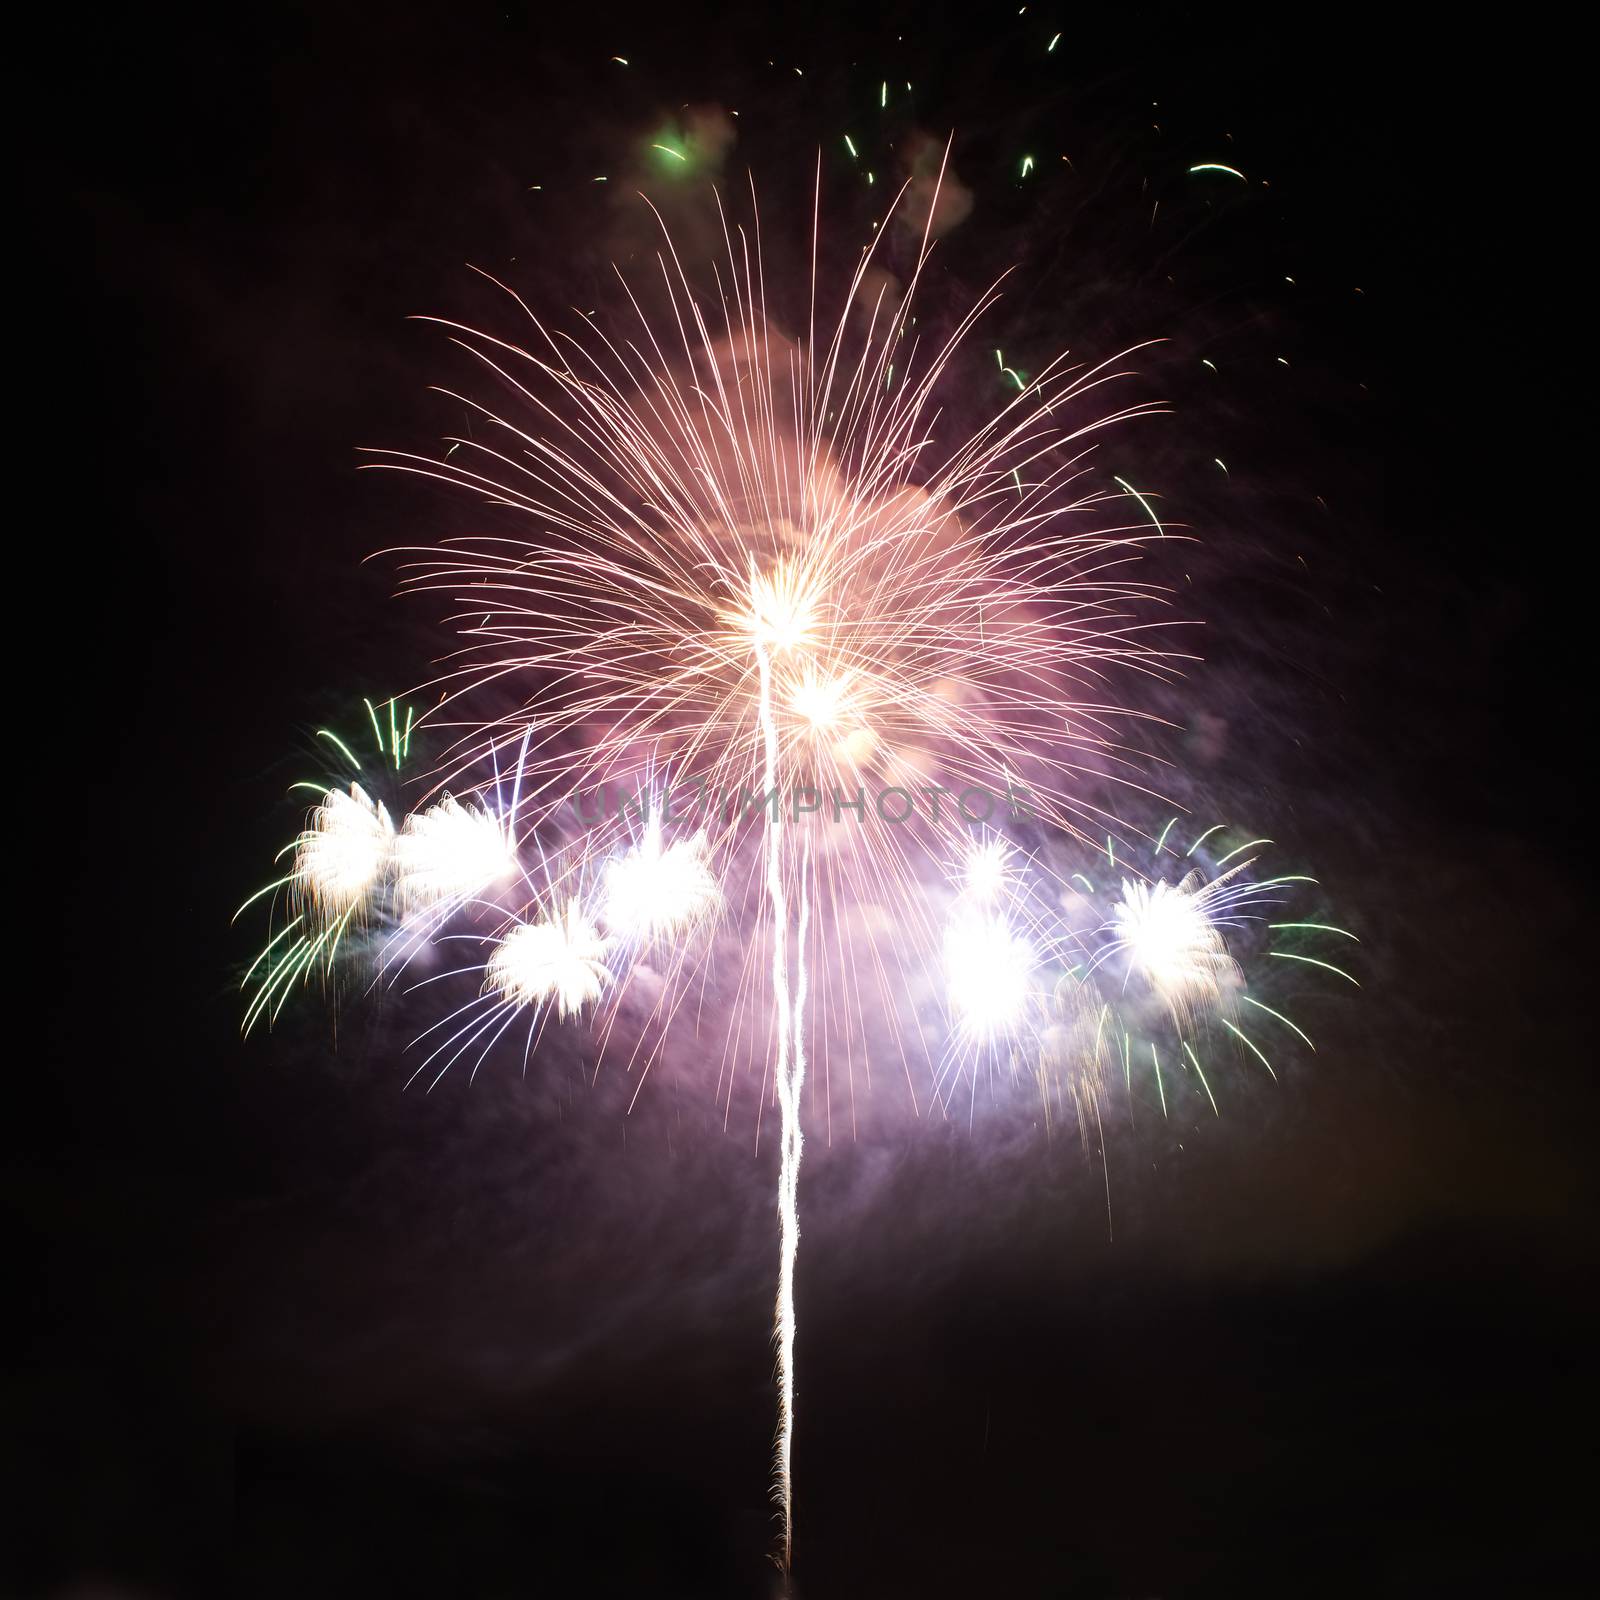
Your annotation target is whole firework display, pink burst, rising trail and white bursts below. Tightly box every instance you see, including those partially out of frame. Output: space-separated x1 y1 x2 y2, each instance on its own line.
246 168 1350 1565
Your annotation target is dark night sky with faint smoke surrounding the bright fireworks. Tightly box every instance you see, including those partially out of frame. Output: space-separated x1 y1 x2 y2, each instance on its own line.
15 5 1595 1597
